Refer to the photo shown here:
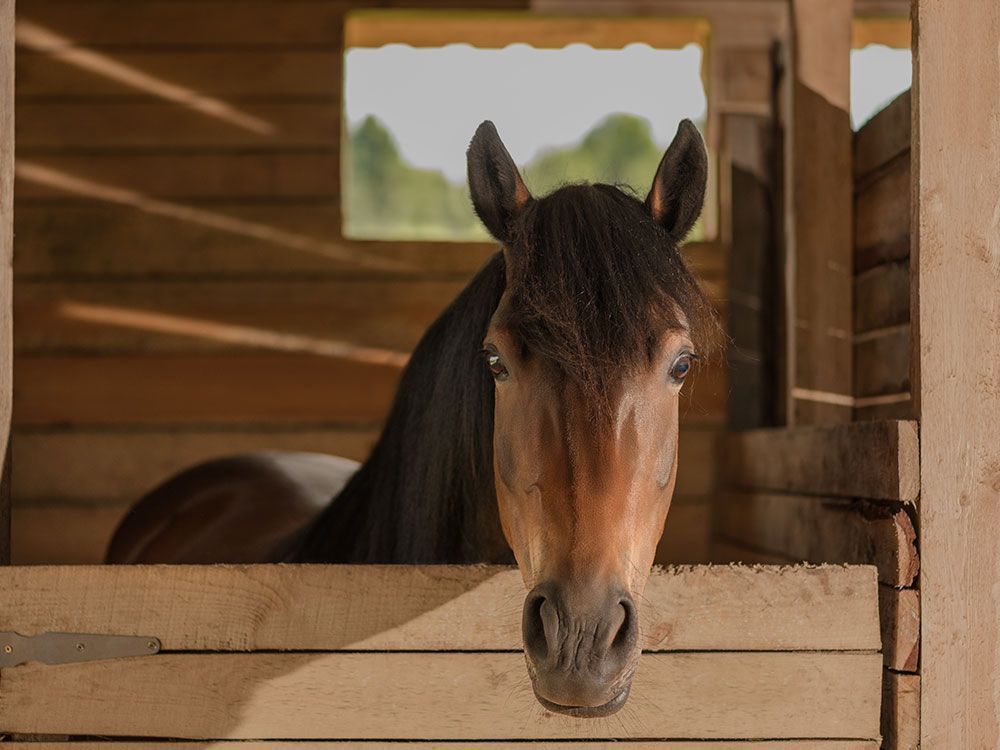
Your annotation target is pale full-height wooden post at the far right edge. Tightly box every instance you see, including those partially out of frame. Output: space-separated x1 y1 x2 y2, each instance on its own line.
911 0 1000 749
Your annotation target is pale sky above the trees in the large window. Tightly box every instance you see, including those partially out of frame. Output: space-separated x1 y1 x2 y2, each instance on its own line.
344 44 706 181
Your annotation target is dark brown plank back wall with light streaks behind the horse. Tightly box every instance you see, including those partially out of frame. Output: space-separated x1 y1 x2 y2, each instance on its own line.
7 0 725 563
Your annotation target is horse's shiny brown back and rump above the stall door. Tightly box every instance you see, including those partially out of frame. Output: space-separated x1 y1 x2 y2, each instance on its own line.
107 452 358 563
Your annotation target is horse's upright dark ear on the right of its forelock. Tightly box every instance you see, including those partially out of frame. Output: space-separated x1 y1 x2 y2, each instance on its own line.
646 120 708 240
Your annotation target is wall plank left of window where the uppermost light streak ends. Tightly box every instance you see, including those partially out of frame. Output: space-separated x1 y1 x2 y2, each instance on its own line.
17 98 340 151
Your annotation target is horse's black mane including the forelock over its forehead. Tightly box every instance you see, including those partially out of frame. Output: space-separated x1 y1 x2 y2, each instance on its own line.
289 184 716 563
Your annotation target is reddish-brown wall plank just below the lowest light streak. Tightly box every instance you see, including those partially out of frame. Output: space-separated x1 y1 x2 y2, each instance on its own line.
14 353 400 426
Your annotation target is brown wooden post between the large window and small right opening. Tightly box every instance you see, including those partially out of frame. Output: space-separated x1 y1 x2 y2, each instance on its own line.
785 0 854 425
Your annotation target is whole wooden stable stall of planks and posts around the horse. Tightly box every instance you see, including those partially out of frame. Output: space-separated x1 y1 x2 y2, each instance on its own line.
0 0 1000 750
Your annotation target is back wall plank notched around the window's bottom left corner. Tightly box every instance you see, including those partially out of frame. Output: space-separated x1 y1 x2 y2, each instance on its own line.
15 201 496 279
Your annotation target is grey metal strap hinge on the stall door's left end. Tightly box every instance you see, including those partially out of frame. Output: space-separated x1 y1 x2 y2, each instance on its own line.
0 632 160 668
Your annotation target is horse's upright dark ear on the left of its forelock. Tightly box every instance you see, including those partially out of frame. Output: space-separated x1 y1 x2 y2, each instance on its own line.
467 120 531 243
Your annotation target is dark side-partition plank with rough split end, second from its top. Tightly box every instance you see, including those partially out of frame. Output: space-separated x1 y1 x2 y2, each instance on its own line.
716 493 920 588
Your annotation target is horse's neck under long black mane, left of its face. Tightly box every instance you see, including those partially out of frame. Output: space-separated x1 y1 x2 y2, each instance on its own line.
293 253 512 563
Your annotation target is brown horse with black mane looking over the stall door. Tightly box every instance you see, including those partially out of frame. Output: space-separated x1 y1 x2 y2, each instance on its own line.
108 121 715 716
